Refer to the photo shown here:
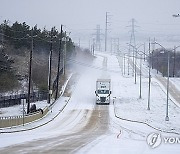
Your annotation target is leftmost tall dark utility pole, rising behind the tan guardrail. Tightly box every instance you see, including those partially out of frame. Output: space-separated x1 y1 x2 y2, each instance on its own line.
27 28 33 114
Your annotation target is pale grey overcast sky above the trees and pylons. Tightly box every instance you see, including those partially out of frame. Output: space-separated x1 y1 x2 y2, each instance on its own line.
0 0 180 47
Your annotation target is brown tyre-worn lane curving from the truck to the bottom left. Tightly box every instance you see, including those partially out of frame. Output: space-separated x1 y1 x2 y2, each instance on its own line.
0 106 109 154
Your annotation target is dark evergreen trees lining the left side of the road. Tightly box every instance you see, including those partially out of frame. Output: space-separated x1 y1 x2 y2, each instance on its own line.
0 20 75 92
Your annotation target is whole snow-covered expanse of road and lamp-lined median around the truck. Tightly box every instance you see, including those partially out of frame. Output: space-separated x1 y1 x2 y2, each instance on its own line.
0 52 180 154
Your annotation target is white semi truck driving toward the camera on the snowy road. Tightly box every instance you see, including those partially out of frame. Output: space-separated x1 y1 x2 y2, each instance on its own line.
95 79 111 104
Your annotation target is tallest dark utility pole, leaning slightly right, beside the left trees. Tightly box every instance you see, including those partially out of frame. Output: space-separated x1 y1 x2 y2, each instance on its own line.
55 25 63 99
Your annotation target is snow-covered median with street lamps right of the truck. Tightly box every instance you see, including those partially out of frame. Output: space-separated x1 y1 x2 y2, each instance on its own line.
111 54 180 134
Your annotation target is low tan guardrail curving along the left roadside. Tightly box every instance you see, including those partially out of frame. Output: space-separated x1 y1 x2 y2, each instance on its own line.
0 107 49 128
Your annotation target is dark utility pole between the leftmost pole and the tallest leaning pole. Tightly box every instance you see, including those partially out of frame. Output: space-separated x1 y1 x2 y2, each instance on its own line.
48 32 52 104
